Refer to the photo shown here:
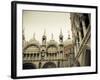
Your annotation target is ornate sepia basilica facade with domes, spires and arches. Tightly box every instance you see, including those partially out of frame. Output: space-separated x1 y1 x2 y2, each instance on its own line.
22 31 74 69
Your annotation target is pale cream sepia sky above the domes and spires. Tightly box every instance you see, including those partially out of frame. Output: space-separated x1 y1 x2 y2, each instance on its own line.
23 10 72 43
